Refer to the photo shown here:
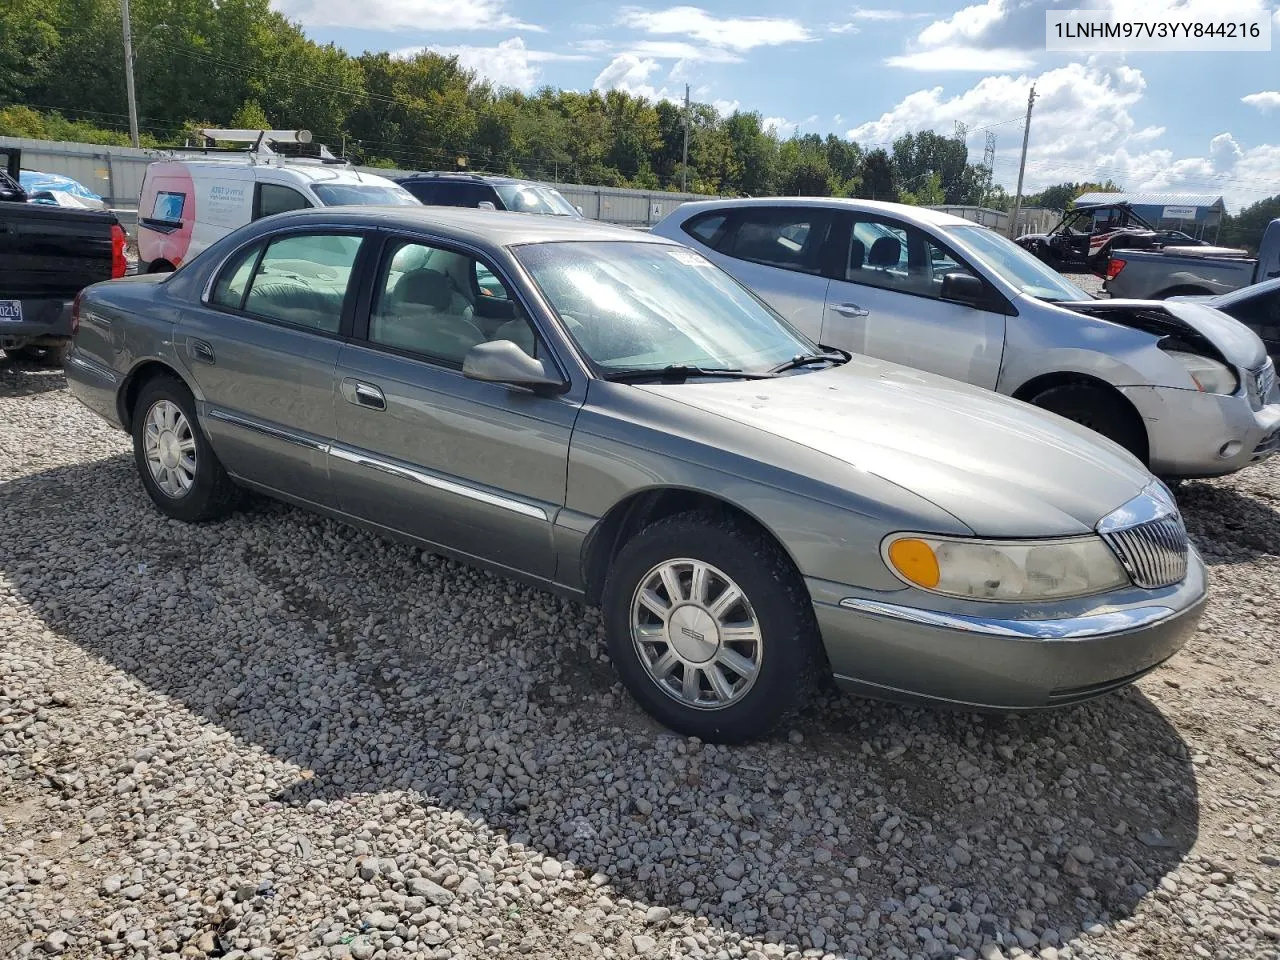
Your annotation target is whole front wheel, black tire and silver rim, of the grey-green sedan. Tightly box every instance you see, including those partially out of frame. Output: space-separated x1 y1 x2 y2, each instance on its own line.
602 513 822 744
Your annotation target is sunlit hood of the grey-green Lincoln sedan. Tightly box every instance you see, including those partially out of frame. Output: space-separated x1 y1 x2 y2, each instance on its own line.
641 357 1151 538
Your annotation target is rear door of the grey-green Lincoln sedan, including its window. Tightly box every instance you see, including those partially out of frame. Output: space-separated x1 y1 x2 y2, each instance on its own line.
175 229 366 504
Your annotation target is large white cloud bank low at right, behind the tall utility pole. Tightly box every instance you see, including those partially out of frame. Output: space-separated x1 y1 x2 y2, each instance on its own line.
847 61 1280 210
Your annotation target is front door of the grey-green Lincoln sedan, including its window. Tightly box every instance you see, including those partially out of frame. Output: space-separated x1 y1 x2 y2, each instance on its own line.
330 238 579 580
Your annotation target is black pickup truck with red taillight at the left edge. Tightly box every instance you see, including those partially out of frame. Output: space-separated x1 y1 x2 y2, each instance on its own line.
0 154 127 366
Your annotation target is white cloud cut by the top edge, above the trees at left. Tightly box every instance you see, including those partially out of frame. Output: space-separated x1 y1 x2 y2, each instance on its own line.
271 0 544 32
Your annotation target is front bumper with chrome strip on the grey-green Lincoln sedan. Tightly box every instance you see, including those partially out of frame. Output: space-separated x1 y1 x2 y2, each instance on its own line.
808 549 1204 710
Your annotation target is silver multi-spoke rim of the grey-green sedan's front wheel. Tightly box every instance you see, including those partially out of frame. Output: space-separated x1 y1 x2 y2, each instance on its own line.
631 559 764 710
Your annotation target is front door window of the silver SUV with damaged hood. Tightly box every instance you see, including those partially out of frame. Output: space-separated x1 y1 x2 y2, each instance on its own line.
845 218 972 297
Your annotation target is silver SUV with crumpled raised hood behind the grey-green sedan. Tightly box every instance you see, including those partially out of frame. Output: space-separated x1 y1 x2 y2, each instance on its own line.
653 197 1280 479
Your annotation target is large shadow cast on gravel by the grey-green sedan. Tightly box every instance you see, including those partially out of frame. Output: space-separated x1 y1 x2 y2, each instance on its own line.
0 456 1211 956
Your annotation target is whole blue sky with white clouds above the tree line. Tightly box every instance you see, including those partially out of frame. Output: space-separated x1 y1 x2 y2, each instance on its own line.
273 0 1280 209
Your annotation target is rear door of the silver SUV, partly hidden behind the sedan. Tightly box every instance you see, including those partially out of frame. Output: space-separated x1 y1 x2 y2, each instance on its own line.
682 205 835 340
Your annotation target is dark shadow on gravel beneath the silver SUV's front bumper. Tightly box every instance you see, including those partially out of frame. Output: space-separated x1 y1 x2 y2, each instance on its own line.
1178 483 1280 566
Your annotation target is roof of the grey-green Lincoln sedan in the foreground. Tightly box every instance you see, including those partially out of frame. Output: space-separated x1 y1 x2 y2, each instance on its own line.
256 205 673 247
